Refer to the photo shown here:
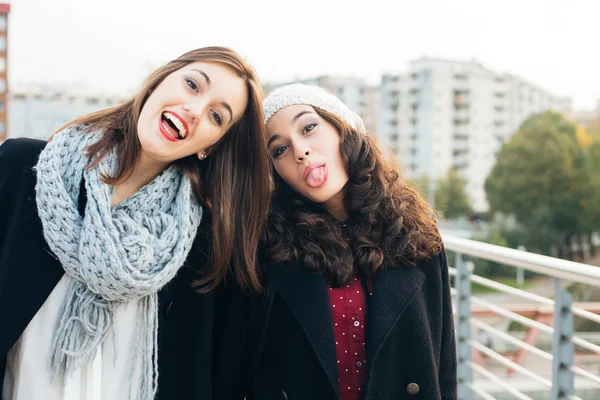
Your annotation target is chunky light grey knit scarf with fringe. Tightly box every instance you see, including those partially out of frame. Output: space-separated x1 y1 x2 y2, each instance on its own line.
36 127 202 400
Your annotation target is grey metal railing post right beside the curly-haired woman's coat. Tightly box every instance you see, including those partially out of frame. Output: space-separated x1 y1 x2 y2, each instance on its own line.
455 253 473 400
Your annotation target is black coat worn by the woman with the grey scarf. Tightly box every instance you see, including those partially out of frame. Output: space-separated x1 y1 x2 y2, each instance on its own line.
0 139 219 400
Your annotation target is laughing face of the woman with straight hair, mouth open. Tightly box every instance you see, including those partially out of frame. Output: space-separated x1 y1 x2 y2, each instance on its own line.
137 61 248 168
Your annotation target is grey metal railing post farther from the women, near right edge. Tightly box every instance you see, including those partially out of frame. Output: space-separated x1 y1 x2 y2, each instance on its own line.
551 279 575 400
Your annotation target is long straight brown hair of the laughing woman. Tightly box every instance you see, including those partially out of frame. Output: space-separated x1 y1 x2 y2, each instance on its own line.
61 47 270 292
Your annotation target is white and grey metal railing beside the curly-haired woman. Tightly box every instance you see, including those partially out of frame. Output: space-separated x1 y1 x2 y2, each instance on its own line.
442 234 600 400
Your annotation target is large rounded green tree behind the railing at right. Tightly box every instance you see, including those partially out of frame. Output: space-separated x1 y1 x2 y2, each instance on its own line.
485 112 593 256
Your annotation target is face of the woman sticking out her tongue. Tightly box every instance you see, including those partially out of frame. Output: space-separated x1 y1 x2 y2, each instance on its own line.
267 105 348 211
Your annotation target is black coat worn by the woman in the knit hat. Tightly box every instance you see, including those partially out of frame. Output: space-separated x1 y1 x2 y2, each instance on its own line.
215 252 457 400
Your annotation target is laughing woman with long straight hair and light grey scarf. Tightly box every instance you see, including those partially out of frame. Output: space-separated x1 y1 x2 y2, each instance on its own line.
0 47 270 400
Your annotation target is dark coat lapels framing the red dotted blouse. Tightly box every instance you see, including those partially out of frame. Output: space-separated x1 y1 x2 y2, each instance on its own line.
264 264 425 396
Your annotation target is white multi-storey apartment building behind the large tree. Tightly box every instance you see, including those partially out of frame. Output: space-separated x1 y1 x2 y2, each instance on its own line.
377 58 571 212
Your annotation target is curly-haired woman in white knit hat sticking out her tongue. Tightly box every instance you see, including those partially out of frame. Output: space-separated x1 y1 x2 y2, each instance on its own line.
217 84 457 400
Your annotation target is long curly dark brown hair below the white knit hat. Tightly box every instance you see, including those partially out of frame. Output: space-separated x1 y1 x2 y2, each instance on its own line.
261 108 442 287
